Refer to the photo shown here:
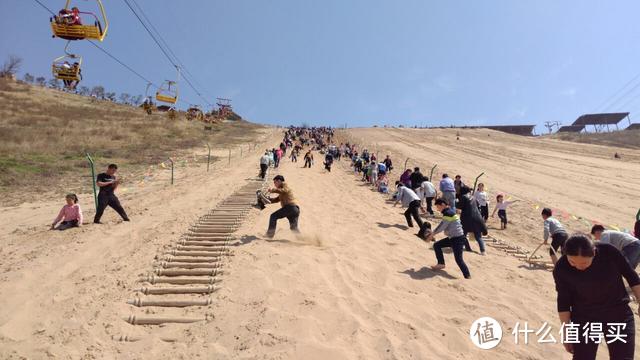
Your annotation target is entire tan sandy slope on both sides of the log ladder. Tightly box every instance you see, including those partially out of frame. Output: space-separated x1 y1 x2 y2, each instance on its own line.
0 129 640 359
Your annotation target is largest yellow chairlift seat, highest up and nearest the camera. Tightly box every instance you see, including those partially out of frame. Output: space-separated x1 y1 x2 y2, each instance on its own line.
49 0 109 41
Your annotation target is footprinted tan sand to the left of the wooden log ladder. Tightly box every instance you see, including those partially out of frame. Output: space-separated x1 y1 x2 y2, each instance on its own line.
0 129 280 359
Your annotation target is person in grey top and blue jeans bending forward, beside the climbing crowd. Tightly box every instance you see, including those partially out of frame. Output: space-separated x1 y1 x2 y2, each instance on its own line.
424 199 471 279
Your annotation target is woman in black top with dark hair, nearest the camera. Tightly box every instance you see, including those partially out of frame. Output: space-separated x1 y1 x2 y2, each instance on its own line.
553 234 640 360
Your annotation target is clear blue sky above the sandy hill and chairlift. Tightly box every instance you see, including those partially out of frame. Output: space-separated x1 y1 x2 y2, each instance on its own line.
0 0 640 131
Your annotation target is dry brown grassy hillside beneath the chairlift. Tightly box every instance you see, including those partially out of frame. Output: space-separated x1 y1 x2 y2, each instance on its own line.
0 78 259 205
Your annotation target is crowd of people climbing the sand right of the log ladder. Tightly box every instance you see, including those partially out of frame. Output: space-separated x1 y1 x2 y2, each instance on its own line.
254 128 640 359
